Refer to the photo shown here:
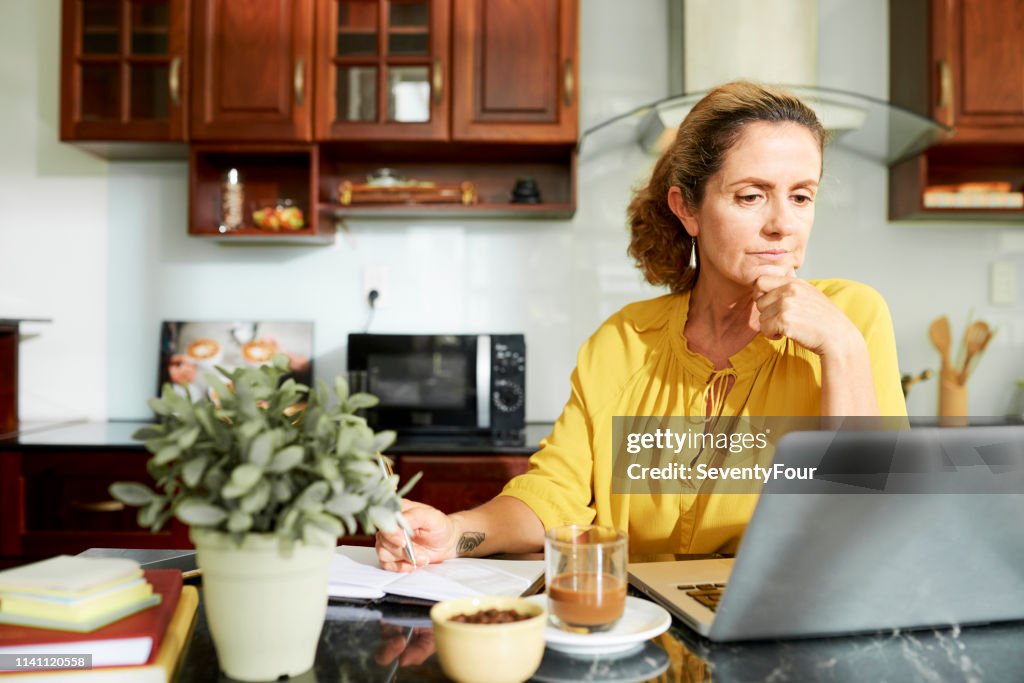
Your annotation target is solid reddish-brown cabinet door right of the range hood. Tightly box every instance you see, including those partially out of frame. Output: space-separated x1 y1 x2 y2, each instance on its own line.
932 0 1024 141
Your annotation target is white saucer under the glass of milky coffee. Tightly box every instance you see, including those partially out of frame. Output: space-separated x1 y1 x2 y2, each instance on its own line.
526 593 672 655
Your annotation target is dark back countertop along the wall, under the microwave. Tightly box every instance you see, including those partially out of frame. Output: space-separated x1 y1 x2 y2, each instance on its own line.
0 420 552 456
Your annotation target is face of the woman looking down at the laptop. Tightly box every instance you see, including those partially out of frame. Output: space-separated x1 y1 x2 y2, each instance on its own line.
670 121 821 286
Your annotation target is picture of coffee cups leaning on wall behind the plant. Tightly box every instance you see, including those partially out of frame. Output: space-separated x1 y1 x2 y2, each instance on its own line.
157 321 313 400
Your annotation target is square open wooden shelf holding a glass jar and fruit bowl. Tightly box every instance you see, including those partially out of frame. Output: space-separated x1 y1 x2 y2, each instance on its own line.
182 144 334 245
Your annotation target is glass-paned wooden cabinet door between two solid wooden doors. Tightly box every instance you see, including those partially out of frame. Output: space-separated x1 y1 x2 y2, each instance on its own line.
316 0 450 140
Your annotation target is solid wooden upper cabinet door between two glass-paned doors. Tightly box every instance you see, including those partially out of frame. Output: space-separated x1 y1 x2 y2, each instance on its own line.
191 0 313 141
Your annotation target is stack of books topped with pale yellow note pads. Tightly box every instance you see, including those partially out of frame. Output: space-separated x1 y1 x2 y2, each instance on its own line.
0 557 199 683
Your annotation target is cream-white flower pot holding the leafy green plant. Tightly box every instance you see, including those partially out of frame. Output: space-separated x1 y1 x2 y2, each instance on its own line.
190 528 335 681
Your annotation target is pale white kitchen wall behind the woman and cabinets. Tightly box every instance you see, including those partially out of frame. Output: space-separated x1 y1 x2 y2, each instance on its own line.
0 0 1024 420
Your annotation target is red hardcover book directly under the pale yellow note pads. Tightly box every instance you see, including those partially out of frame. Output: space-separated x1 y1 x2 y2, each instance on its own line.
0 569 181 667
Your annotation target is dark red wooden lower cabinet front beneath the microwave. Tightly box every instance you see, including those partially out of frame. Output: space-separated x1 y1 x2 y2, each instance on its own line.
397 455 529 514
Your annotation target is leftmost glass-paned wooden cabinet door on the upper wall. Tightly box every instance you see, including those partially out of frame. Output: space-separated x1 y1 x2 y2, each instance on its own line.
60 0 188 141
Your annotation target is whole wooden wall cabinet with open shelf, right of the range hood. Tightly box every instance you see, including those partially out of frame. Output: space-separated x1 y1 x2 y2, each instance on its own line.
889 0 1024 221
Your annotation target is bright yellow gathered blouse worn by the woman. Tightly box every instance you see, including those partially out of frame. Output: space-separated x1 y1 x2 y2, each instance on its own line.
502 280 906 556
